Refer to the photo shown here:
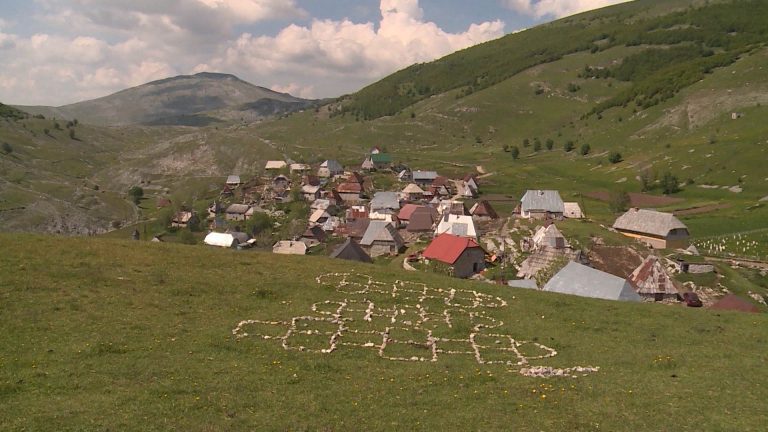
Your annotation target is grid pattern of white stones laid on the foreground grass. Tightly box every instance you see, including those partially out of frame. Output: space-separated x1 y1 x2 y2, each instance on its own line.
232 273 599 378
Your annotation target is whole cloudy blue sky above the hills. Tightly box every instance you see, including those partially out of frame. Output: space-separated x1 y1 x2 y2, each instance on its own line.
0 0 627 106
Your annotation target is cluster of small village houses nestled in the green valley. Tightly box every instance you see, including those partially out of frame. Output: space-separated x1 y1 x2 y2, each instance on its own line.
153 147 765 312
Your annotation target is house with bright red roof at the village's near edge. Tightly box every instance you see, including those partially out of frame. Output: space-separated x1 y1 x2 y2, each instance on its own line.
423 234 485 278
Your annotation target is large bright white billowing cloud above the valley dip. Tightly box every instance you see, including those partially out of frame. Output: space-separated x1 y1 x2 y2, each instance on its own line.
209 0 504 97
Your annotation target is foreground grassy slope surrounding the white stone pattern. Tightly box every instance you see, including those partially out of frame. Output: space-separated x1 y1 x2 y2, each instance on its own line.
0 234 768 431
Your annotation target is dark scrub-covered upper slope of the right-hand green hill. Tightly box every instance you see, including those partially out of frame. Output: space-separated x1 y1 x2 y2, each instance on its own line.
341 0 768 120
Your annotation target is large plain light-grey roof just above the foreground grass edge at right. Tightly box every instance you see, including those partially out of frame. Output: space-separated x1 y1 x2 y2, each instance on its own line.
544 261 642 301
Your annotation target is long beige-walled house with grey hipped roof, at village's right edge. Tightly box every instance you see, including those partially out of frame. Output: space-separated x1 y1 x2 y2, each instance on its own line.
613 208 690 249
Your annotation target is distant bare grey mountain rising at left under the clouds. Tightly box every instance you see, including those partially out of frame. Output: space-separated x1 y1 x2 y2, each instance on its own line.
17 72 317 126
